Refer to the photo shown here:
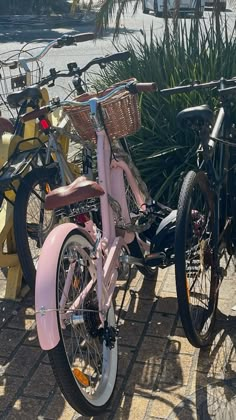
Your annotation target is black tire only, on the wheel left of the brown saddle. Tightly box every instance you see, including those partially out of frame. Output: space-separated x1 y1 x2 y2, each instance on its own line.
13 167 57 291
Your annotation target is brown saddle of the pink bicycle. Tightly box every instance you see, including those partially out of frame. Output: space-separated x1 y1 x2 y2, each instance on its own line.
45 176 104 210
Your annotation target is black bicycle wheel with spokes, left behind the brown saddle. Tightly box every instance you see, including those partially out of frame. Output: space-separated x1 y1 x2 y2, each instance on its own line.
14 167 59 290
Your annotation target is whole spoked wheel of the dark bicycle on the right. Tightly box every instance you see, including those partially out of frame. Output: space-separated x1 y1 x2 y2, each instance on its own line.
175 171 219 347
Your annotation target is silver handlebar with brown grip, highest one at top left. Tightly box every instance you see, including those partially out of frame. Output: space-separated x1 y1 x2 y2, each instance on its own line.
0 32 95 68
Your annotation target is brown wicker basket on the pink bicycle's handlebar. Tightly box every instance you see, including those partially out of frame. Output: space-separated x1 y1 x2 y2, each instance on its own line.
64 79 141 141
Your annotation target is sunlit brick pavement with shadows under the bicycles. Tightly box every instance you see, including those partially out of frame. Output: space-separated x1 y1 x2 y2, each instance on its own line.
0 262 236 420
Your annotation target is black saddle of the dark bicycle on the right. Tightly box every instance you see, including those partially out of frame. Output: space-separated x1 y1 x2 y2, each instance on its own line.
176 105 214 128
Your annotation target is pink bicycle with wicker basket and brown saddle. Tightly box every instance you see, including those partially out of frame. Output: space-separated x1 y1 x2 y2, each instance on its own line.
35 80 174 416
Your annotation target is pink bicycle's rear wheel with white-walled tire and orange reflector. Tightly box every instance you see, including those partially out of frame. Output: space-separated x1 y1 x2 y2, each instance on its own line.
48 229 118 416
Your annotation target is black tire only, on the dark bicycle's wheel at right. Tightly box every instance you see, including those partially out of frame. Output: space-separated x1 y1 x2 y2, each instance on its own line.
175 171 218 348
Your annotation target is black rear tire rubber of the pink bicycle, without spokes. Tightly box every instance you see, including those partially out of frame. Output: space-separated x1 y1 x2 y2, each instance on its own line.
48 229 118 416
